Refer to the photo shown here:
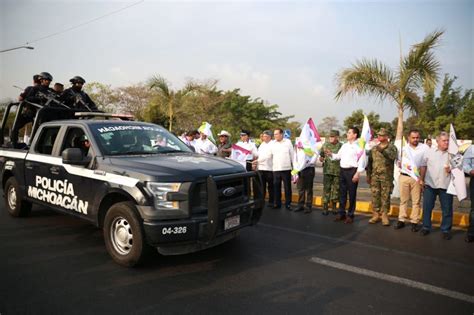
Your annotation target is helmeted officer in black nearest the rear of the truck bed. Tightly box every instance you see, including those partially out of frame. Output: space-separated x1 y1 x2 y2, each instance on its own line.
10 72 55 147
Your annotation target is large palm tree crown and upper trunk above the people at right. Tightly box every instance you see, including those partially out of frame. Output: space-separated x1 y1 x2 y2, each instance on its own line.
335 31 444 139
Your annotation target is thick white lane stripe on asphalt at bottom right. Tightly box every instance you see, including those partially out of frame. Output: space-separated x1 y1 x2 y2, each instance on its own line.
310 257 474 304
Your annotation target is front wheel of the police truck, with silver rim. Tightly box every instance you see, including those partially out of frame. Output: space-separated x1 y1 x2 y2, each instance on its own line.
103 202 151 267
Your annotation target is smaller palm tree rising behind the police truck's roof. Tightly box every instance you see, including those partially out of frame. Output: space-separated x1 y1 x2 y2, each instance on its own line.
147 75 200 132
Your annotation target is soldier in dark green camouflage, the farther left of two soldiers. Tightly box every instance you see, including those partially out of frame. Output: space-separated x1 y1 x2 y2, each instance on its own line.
319 130 342 215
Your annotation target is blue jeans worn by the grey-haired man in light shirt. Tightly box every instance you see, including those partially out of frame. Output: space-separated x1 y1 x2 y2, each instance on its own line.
423 185 453 232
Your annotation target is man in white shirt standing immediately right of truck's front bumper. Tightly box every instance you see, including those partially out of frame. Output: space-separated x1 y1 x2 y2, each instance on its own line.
254 130 275 206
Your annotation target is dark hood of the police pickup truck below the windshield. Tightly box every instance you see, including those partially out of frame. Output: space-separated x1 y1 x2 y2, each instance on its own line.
106 153 245 182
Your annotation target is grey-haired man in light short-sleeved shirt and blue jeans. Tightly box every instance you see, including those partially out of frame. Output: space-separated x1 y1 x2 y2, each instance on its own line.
420 131 453 240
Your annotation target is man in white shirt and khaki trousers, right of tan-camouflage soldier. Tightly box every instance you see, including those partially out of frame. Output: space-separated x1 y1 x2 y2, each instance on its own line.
395 129 429 232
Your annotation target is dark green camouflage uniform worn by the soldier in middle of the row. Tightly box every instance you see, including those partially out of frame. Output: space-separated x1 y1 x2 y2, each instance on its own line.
320 142 342 206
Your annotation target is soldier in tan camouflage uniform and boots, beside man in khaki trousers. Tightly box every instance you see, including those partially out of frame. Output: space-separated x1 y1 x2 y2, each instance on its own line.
367 128 398 226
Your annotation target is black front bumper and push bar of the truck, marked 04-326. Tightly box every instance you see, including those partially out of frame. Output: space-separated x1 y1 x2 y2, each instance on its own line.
142 172 264 255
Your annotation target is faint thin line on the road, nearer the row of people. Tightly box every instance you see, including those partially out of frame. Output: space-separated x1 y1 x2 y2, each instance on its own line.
258 222 474 270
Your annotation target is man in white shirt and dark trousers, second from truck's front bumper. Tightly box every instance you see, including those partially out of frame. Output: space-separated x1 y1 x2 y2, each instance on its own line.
271 128 294 211
